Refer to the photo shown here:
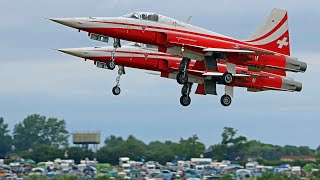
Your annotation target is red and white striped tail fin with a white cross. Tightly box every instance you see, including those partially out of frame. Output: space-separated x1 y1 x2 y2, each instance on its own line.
246 9 290 56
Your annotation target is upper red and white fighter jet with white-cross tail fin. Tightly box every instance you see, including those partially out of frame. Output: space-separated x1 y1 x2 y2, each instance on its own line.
51 9 307 106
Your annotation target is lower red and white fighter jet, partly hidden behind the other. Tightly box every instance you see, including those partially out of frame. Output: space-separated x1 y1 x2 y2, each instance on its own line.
59 43 302 106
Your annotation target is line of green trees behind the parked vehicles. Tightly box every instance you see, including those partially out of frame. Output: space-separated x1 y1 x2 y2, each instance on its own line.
0 114 320 164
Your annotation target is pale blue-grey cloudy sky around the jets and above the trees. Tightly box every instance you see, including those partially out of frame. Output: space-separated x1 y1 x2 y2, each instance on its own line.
0 0 320 148
